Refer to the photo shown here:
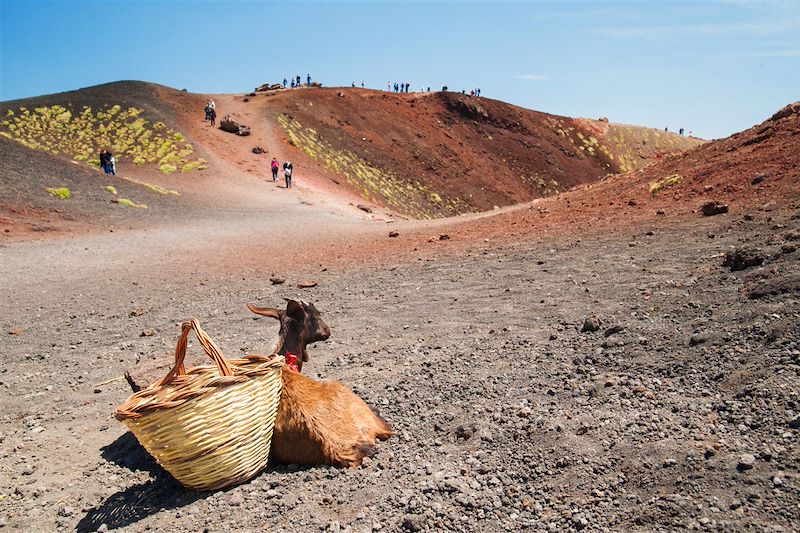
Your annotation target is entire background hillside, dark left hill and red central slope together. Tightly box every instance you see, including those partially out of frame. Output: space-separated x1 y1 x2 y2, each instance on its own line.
0 81 702 235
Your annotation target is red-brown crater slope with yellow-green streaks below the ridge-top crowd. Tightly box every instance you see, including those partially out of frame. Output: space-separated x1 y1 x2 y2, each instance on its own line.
262 89 702 218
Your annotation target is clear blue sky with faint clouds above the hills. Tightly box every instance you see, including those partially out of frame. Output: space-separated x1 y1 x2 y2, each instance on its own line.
0 0 800 138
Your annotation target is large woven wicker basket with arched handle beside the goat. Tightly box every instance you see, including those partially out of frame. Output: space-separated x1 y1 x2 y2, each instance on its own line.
116 319 283 490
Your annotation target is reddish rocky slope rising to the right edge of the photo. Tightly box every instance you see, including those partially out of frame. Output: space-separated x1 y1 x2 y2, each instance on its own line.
456 102 800 244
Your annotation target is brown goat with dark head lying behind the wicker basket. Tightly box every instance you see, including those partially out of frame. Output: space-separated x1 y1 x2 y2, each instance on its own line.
247 299 392 466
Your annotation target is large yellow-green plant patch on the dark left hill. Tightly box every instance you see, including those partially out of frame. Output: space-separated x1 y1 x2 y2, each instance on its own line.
0 105 207 174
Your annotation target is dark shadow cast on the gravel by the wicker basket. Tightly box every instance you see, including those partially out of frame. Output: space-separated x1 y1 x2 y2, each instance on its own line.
75 432 207 532
